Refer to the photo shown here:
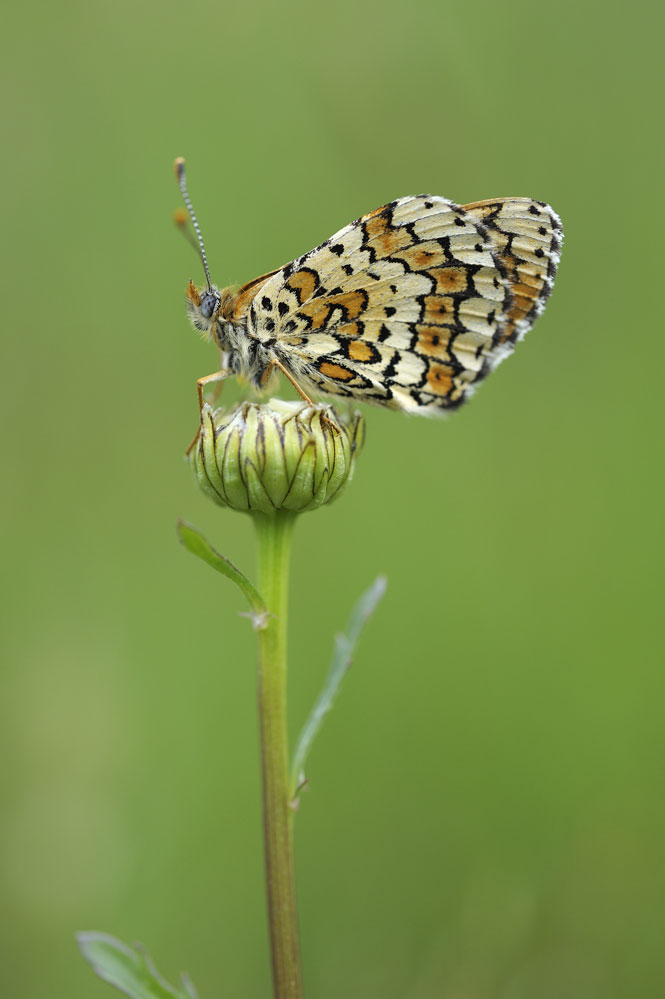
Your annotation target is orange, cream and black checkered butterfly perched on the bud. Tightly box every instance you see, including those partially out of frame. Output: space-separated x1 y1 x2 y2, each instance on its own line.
175 159 563 415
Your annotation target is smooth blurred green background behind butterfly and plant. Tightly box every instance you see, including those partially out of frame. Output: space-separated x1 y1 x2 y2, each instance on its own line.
0 0 665 999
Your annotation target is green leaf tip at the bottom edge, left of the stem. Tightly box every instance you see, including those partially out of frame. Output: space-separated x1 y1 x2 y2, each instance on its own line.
76 931 196 999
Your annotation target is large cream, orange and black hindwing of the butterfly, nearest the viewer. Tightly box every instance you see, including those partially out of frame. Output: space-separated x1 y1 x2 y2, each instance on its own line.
247 195 560 412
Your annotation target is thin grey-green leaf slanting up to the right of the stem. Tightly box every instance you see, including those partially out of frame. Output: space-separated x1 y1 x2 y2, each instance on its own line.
290 576 388 801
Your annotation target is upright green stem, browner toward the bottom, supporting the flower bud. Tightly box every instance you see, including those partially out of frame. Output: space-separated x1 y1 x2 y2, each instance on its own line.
254 511 302 999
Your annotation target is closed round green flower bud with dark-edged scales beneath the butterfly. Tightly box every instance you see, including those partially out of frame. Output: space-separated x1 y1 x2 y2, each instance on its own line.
190 399 364 513
